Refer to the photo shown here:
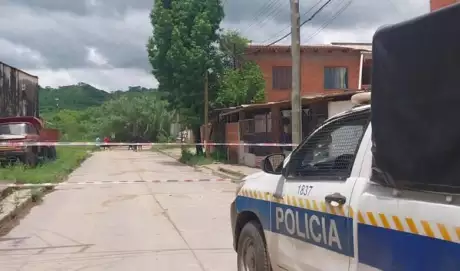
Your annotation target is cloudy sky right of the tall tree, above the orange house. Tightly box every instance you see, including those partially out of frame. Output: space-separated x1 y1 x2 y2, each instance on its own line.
225 0 429 42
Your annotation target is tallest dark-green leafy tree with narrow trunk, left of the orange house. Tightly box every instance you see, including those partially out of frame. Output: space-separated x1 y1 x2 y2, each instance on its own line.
147 0 224 153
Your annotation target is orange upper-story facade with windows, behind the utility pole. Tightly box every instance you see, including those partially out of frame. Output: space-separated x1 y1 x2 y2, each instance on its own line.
246 43 372 102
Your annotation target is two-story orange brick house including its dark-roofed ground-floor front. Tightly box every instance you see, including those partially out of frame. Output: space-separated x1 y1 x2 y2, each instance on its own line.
210 43 372 166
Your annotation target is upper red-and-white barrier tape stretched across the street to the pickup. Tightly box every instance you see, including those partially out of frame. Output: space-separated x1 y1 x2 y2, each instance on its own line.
0 141 297 147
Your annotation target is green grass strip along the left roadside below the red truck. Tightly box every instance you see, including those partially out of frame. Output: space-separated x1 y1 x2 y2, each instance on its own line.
0 147 92 183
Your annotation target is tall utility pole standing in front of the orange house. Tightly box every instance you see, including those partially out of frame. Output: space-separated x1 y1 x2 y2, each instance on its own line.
291 0 302 144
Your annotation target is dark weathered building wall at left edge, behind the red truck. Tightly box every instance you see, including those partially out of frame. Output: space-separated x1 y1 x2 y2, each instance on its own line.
0 62 39 117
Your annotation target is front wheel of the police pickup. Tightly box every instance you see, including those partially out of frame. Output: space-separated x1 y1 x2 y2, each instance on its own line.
237 221 272 271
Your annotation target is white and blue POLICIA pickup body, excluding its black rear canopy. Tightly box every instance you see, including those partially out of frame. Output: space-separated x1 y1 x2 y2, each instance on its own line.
231 98 460 271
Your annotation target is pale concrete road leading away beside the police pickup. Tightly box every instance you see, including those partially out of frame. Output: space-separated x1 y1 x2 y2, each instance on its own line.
0 150 236 271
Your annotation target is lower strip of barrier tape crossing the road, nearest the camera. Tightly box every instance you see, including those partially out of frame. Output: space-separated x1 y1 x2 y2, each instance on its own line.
0 178 234 188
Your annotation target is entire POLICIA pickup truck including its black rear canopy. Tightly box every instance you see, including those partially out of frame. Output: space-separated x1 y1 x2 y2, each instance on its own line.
231 5 460 271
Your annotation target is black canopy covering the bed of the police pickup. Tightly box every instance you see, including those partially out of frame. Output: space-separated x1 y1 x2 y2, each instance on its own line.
371 4 460 193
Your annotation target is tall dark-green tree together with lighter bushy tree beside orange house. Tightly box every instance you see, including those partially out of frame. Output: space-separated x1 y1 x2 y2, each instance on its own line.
147 0 264 154
